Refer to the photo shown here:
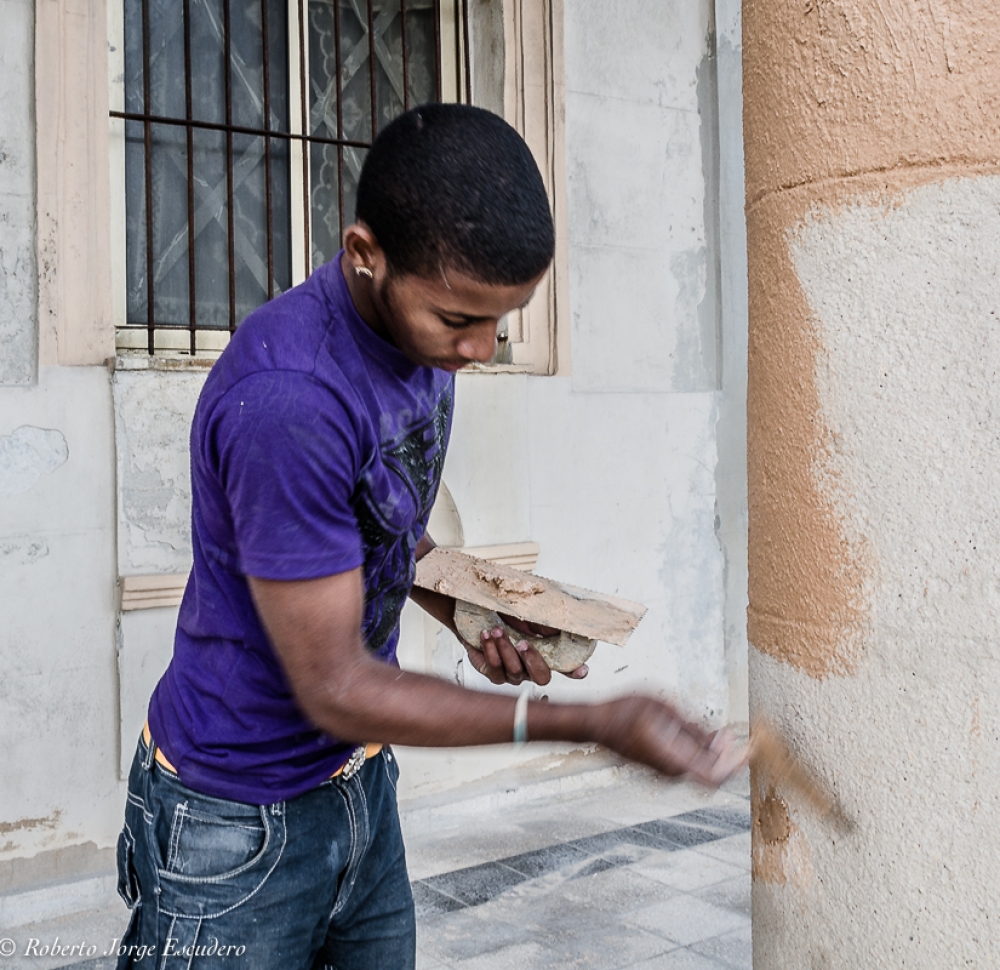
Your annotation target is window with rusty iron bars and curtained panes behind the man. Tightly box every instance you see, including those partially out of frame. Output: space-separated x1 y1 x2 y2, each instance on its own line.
111 0 471 357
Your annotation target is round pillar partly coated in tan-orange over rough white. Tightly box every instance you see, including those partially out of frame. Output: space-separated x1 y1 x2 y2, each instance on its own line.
743 0 1000 970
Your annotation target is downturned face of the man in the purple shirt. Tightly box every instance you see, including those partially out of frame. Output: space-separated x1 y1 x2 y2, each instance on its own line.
372 269 545 371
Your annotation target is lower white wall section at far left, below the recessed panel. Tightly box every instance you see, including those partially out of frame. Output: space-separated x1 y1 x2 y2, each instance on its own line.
0 368 124 862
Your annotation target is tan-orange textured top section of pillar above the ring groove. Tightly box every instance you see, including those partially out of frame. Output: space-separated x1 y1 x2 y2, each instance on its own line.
743 0 1000 202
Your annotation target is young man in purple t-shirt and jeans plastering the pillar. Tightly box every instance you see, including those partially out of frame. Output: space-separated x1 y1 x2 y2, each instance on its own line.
119 105 738 970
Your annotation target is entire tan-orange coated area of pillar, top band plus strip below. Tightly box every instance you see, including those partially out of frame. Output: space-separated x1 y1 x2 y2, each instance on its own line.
743 0 1000 678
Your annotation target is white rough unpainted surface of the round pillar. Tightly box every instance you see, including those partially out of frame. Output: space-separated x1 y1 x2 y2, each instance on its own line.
752 177 1000 970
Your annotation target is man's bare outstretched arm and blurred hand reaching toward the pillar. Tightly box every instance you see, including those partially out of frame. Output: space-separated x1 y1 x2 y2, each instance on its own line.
243 569 741 784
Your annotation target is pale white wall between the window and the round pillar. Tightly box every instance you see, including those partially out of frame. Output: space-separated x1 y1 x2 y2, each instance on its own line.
400 0 746 795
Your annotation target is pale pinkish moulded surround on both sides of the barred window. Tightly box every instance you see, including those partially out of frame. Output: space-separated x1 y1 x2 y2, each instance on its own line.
35 0 570 375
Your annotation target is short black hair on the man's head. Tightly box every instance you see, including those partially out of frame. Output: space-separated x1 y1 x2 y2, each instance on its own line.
355 104 555 285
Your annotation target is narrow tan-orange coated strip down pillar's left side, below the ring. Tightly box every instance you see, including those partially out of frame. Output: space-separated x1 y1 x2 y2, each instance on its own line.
747 185 865 678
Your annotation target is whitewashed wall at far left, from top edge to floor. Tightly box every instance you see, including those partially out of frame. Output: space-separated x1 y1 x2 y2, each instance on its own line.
0 0 123 876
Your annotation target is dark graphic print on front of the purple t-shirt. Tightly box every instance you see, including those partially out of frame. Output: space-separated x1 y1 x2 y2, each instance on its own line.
352 385 454 653
